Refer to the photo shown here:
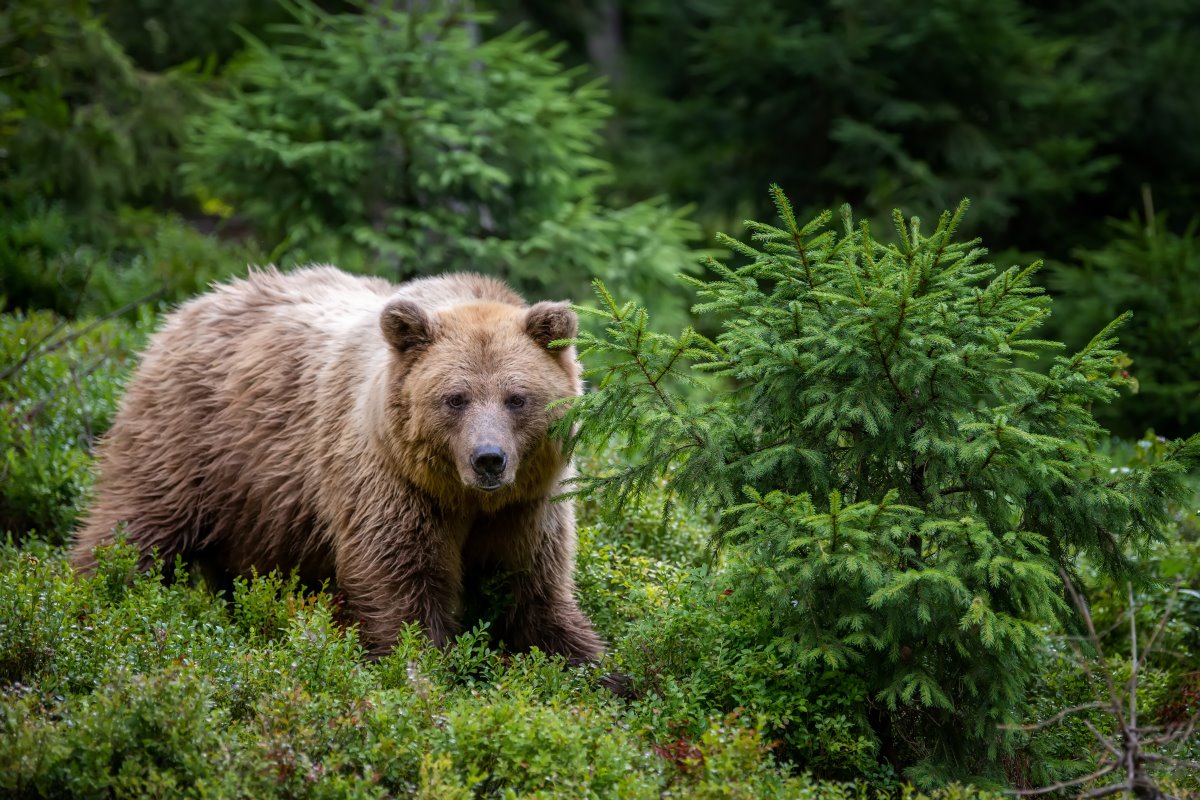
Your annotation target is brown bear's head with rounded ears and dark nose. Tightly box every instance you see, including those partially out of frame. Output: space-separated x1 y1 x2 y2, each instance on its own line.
380 299 581 506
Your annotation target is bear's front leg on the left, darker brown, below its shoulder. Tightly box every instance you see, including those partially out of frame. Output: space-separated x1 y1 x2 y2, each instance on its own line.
336 509 462 657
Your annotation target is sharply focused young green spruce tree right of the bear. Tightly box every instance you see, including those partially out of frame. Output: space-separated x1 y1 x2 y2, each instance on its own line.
563 187 1200 781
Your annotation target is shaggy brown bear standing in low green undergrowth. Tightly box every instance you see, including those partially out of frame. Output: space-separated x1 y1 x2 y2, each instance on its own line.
73 266 602 662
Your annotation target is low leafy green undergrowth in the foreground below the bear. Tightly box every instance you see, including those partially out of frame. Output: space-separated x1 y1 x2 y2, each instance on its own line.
0 541 1003 800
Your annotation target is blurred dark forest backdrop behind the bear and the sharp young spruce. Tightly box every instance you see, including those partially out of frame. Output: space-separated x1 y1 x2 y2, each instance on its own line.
0 0 1200 435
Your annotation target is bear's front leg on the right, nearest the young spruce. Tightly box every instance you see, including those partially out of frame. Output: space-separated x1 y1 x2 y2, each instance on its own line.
484 500 604 663
